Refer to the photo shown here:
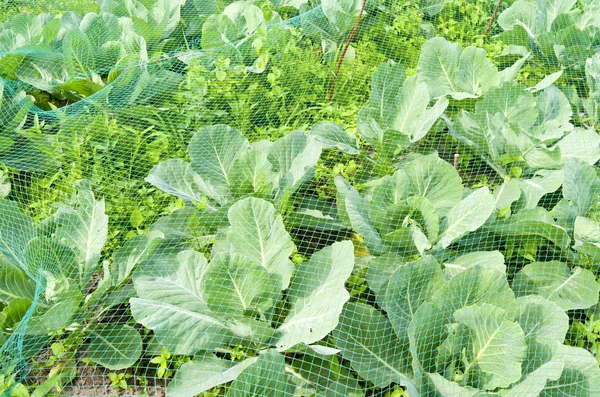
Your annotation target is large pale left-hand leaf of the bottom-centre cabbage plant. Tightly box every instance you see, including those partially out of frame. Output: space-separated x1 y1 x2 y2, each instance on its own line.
130 250 230 354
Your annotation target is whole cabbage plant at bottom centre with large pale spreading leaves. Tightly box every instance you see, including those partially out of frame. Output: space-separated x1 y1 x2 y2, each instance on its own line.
131 198 354 396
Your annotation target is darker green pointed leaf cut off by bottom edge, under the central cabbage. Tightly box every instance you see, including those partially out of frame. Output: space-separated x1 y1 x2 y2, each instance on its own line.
226 350 294 397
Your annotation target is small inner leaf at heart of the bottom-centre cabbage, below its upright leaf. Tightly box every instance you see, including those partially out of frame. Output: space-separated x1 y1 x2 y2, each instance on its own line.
203 254 281 319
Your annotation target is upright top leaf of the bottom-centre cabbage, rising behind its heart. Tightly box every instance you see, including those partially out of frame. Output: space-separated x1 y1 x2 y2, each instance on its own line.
227 197 294 289
